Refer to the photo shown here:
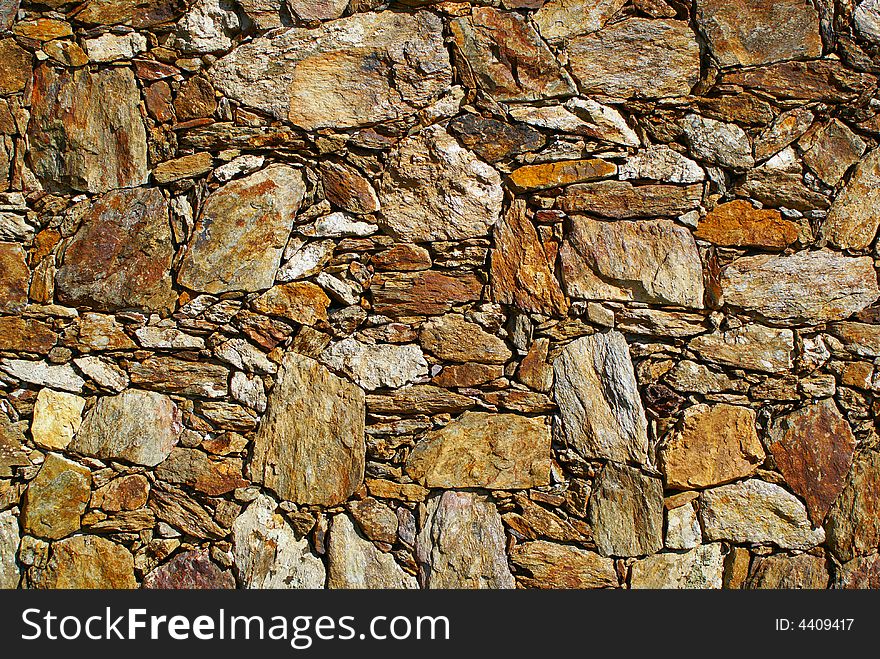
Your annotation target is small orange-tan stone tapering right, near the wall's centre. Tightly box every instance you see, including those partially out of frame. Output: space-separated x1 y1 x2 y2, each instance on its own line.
419 314 511 364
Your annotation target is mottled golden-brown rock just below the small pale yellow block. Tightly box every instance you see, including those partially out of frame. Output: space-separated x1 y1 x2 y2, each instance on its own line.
21 453 92 540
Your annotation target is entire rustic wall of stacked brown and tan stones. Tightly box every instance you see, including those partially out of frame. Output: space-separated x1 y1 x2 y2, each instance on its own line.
0 0 880 588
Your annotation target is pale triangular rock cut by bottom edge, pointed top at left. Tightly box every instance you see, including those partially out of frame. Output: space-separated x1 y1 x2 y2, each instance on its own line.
327 513 419 589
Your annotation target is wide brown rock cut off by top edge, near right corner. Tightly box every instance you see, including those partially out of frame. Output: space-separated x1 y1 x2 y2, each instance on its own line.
696 0 822 67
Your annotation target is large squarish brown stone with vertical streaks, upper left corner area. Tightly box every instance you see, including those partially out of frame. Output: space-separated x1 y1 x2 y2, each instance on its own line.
28 64 148 192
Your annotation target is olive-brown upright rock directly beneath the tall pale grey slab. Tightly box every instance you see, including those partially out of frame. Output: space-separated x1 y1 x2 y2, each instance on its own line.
589 462 663 557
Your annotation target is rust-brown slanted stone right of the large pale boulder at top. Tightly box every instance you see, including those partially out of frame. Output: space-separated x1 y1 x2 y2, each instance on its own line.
450 7 577 101
